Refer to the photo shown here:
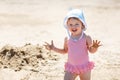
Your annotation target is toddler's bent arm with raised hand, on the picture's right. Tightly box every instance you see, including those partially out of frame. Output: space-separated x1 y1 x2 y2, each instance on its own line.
86 36 101 53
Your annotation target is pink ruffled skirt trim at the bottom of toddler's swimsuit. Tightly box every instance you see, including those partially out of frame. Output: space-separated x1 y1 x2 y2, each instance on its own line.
65 62 94 74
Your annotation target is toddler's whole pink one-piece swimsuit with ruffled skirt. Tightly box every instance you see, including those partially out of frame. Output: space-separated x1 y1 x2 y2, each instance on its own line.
65 34 94 74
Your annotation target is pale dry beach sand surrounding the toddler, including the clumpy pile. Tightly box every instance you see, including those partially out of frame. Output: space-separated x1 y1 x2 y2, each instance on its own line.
0 0 120 80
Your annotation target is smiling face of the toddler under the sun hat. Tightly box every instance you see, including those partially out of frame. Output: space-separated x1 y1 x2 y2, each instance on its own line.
67 18 84 36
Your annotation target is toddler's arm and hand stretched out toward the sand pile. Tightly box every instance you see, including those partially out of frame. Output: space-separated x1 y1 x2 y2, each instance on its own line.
44 37 68 54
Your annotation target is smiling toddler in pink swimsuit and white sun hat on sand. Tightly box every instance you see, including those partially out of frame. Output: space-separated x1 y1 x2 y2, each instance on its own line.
45 9 101 80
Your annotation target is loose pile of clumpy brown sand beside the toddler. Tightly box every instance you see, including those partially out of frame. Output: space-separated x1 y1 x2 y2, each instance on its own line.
0 43 59 72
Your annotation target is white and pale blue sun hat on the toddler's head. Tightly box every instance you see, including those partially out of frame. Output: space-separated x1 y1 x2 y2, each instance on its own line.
64 9 87 31
